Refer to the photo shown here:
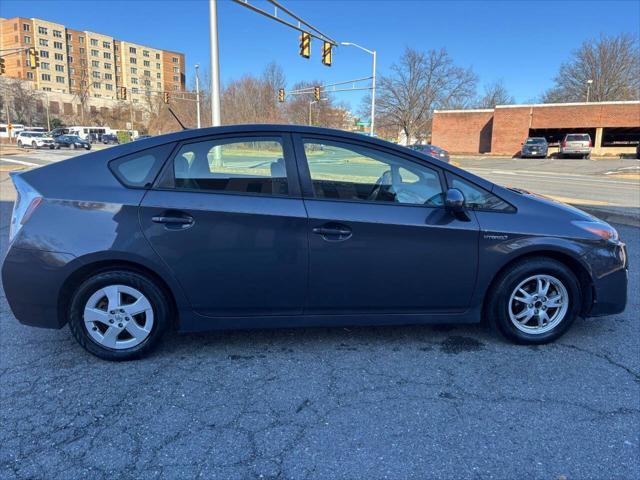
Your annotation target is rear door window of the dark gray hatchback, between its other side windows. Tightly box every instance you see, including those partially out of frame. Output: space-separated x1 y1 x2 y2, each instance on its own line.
173 137 289 195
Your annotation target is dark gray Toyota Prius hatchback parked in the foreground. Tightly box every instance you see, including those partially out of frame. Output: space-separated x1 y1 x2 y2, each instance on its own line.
2 125 627 360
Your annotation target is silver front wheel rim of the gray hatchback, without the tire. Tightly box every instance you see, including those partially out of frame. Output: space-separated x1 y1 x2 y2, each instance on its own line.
509 275 569 335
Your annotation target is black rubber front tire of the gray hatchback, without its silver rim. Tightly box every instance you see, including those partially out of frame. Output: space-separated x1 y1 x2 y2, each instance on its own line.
489 258 582 345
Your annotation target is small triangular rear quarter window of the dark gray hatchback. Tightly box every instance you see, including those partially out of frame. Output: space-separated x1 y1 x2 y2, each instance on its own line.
109 143 175 188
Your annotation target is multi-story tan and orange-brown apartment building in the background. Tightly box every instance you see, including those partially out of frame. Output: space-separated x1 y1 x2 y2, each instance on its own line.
0 17 185 103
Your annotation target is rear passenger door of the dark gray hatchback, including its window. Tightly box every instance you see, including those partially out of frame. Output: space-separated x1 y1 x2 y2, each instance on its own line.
140 132 308 316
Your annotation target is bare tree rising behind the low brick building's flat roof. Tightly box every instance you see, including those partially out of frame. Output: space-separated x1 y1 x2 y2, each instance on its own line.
543 33 640 103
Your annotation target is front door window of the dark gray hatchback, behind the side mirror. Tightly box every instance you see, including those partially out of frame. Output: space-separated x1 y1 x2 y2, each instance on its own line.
303 139 443 207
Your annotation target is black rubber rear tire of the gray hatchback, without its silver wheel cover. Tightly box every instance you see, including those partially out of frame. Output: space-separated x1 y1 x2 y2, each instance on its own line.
68 271 170 361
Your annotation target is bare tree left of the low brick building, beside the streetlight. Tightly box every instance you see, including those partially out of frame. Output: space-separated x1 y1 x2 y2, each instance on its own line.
377 48 477 143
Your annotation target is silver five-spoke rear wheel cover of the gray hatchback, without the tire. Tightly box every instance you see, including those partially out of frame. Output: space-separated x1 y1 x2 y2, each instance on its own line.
84 285 154 350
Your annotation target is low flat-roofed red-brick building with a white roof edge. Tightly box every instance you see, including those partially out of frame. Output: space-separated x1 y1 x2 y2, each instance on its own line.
431 102 640 155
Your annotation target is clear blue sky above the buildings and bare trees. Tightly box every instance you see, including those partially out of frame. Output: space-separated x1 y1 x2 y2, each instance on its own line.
0 0 640 107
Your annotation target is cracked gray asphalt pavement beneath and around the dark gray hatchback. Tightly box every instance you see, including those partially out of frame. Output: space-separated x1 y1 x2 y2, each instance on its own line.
0 151 640 480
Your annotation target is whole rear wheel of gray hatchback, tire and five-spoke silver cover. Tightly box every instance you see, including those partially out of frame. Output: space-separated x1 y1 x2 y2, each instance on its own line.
69 270 170 361
